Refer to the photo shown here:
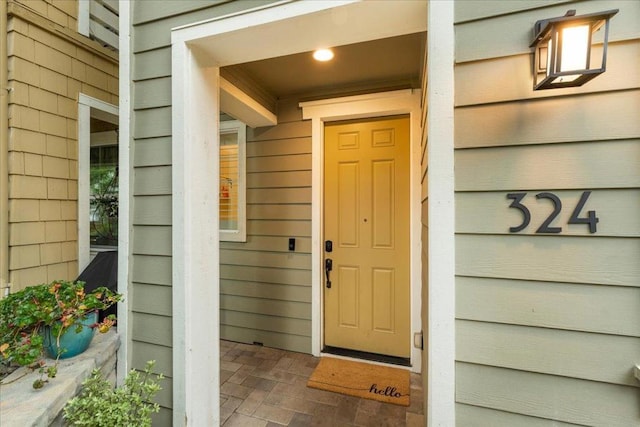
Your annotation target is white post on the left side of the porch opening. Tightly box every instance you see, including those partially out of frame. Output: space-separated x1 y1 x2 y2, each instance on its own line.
172 40 220 426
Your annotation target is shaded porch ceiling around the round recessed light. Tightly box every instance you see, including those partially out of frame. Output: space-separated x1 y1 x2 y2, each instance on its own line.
221 32 426 100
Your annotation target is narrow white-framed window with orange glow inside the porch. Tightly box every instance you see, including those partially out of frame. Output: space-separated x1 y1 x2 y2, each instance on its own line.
219 120 247 242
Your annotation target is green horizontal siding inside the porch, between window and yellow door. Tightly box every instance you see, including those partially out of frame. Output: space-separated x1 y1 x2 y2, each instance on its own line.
220 100 311 352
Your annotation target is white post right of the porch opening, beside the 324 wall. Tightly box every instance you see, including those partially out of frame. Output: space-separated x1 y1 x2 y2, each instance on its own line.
426 1 456 427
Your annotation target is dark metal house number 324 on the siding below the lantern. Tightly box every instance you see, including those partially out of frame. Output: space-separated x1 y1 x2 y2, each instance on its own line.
507 191 599 234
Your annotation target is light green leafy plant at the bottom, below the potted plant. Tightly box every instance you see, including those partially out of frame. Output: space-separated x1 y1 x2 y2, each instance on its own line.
64 360 164 427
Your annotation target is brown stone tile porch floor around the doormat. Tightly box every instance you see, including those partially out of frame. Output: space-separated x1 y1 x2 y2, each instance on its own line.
220 341 424 427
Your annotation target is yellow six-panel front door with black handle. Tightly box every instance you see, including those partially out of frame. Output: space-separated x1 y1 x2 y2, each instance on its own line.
323 117 410 358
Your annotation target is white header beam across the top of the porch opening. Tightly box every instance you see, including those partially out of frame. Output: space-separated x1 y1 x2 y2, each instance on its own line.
172 0 427 67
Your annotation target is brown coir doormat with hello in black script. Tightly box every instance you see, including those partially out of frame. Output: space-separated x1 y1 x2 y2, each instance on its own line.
307 357 410 406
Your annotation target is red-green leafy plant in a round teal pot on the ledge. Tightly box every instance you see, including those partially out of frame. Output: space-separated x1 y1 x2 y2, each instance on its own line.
0 281 122 388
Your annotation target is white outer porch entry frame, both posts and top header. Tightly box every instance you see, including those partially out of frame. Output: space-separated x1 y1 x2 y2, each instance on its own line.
168 0 455 425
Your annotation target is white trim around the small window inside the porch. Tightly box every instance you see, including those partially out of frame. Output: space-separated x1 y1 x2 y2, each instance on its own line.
220 120 247 242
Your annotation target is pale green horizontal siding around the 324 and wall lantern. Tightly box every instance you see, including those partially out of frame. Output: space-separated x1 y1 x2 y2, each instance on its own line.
455 0 640 426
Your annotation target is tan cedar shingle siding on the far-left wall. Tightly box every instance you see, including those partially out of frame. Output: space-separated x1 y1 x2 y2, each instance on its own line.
7 0 118 291
